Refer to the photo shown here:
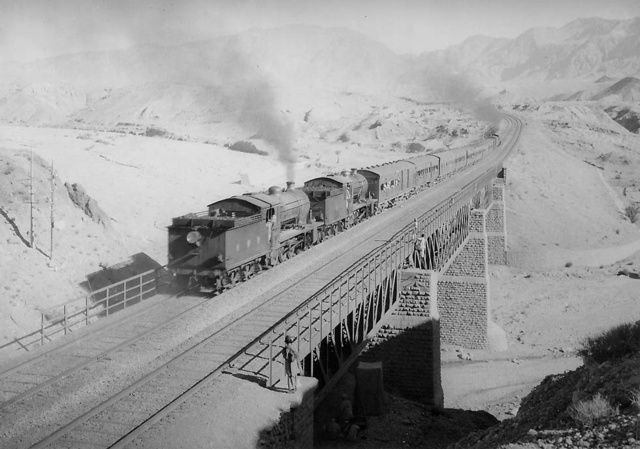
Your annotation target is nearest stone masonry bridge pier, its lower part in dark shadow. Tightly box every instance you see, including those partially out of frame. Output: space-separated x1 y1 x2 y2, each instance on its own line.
358 269 444 408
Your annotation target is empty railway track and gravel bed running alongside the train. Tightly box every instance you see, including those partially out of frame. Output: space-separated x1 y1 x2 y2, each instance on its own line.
0 114 524 448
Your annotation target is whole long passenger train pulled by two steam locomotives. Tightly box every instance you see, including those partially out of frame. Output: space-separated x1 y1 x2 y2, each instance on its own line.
168 134 500 291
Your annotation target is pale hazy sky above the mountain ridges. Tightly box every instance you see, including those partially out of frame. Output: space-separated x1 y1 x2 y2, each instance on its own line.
0 0 640 61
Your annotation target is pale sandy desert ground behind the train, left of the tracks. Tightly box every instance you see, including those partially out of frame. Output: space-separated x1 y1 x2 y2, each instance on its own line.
0 98 487 350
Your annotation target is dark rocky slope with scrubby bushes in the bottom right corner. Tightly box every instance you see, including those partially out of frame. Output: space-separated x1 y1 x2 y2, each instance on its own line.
451 354 640 449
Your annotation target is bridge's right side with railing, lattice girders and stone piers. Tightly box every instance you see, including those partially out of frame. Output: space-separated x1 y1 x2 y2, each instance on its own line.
235 159 506 398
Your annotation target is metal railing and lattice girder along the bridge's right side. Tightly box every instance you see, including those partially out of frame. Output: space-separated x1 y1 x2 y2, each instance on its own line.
228 161 501 386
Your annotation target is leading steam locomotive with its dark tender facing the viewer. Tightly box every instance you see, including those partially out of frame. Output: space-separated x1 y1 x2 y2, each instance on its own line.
168 184 309 288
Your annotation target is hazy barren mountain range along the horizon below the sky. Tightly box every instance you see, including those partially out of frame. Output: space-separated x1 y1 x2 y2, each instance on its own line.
0 18 640 133
